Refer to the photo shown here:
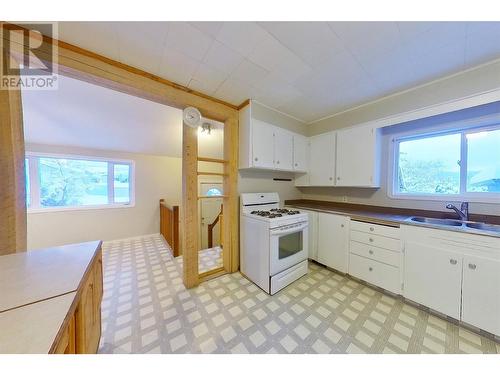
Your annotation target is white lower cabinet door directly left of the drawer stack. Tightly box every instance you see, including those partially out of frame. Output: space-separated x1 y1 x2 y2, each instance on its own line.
318 212 350 273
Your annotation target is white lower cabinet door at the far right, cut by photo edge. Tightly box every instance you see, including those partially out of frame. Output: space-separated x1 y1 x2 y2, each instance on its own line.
462 256 500 336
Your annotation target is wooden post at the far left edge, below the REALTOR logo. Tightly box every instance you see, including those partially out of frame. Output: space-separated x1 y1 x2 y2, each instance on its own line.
0 49 26 255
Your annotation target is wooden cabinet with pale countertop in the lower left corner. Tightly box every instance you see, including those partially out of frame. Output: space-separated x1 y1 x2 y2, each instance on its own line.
0 241 103 354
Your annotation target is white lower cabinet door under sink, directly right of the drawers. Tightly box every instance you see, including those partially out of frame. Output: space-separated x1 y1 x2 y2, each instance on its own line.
403 241 462 319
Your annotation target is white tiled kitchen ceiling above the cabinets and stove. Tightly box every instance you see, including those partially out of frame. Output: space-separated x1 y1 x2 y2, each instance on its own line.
52 22 500 122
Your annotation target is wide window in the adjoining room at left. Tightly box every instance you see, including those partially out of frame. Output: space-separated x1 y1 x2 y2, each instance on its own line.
26 153 133 210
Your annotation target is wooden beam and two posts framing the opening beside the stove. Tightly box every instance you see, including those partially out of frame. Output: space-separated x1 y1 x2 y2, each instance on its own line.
0 22 239 288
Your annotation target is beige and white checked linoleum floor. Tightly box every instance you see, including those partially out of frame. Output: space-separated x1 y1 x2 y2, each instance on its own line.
99 236 500 353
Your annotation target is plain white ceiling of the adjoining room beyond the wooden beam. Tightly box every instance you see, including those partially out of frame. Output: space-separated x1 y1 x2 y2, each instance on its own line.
22 76 223 157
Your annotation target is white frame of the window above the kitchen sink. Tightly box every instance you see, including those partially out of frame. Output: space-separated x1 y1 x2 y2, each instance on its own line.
387 121 500 204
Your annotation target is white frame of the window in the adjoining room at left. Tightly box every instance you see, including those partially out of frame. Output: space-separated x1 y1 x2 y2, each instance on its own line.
25 151 135 214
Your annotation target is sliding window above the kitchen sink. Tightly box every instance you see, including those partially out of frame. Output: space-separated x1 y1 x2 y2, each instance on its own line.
392 126 500 201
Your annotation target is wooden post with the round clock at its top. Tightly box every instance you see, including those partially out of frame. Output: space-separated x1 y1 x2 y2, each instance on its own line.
182 124 200 288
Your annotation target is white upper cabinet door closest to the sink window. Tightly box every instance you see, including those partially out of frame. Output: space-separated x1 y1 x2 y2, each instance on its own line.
336 127 380 187
